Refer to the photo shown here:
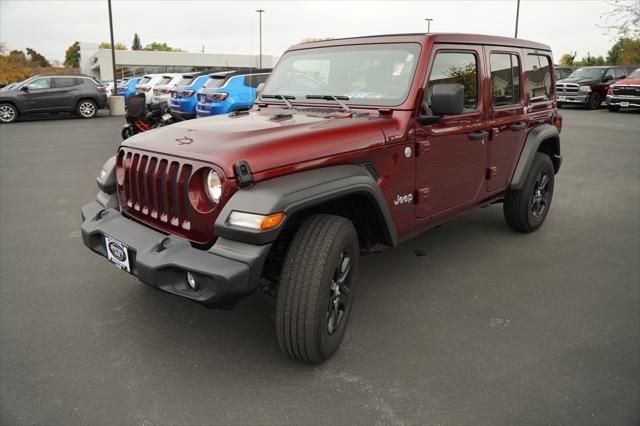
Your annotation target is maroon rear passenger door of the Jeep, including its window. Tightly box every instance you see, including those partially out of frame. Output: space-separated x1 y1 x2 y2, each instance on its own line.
485 46 527 192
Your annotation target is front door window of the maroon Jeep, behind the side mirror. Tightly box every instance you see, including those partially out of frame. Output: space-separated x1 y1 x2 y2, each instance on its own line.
426 52 478 112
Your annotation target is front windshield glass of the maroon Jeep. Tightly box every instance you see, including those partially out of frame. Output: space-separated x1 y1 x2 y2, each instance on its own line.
262 43 420 106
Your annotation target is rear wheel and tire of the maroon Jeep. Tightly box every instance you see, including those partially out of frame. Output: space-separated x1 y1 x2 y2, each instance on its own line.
503 152 555 232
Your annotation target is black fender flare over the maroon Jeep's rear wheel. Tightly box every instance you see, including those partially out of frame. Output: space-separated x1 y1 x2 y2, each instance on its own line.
509 124 562 190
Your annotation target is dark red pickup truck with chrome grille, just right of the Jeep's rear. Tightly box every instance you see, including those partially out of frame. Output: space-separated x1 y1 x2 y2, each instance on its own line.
556 66 631 109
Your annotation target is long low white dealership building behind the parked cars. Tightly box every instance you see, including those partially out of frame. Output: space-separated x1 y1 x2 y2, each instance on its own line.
80 43 276 80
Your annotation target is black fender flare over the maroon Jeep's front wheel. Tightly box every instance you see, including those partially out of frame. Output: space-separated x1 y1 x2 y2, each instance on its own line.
214 165 398 245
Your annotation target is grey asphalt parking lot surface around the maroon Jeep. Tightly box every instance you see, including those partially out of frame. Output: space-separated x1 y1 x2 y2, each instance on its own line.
0 108 640 425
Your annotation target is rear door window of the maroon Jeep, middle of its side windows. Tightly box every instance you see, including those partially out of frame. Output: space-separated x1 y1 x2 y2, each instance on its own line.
490 53 520 106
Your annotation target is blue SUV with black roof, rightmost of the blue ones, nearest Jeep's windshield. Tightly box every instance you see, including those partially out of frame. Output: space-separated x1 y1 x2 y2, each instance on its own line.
196 68 271 117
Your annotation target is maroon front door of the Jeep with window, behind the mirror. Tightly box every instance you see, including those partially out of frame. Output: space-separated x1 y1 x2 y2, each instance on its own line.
415 45 489 218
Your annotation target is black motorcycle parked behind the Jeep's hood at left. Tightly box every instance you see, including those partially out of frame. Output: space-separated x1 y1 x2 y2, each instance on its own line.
120 93 183 140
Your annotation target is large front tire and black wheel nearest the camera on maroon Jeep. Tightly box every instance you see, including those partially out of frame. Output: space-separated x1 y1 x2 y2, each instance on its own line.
276 214 360 364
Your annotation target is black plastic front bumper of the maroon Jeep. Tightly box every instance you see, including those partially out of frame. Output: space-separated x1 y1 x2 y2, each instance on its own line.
82 198 271 307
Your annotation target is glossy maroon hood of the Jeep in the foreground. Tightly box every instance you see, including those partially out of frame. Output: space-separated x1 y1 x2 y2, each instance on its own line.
122 108 390 177
